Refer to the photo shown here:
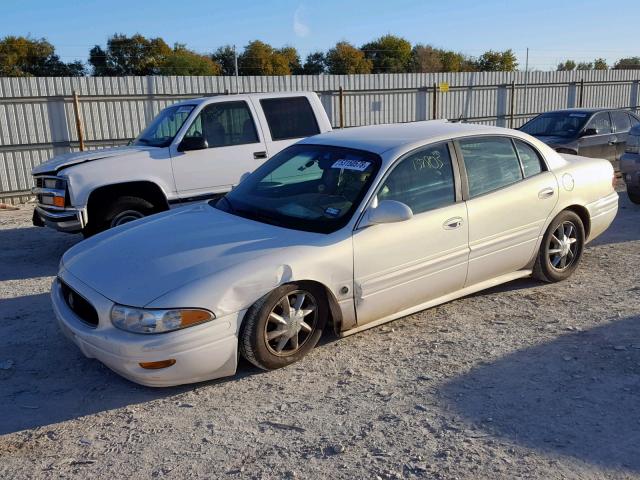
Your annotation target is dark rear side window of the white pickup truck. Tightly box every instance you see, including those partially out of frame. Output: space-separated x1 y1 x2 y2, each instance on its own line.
260 97 320 140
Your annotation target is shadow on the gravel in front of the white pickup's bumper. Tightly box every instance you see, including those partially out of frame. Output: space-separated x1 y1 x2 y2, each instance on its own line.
0 227 82 282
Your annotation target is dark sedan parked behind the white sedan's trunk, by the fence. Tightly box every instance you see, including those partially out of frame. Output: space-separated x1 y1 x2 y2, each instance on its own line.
520 108 640 166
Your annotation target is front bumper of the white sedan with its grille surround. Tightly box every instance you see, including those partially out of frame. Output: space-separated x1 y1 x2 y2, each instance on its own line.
51 270 245 387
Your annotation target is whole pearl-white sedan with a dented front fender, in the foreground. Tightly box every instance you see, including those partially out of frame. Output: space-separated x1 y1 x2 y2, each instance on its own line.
51 121 618 386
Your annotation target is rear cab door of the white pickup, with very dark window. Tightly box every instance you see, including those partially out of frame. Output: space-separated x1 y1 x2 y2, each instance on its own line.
252 96 320 157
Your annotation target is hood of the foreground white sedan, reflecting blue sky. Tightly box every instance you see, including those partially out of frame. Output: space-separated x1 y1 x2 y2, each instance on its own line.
62 203 320 307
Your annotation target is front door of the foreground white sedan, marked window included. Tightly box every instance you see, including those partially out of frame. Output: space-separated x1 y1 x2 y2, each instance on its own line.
353 143 468 325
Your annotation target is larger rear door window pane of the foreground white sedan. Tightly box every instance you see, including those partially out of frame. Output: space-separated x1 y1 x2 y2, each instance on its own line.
458 137 522 198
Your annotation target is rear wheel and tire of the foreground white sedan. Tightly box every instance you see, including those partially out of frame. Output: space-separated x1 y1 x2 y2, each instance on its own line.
533 210 585 282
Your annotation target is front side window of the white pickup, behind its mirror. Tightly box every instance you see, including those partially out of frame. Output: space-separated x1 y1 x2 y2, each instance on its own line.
185 101 260 148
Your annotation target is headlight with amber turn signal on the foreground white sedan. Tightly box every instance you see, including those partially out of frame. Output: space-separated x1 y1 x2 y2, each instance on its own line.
111 305 216 333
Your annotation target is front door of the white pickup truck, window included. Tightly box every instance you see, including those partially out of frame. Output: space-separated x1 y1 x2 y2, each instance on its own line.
171 100 267 199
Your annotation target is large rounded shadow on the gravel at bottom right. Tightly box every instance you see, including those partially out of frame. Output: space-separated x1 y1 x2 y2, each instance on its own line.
440 315 640 471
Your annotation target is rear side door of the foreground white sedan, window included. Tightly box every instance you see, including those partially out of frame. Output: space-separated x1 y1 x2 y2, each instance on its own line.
457 136 558 286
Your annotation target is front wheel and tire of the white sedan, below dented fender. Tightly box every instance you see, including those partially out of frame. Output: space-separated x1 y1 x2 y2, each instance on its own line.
238 283 329 370
